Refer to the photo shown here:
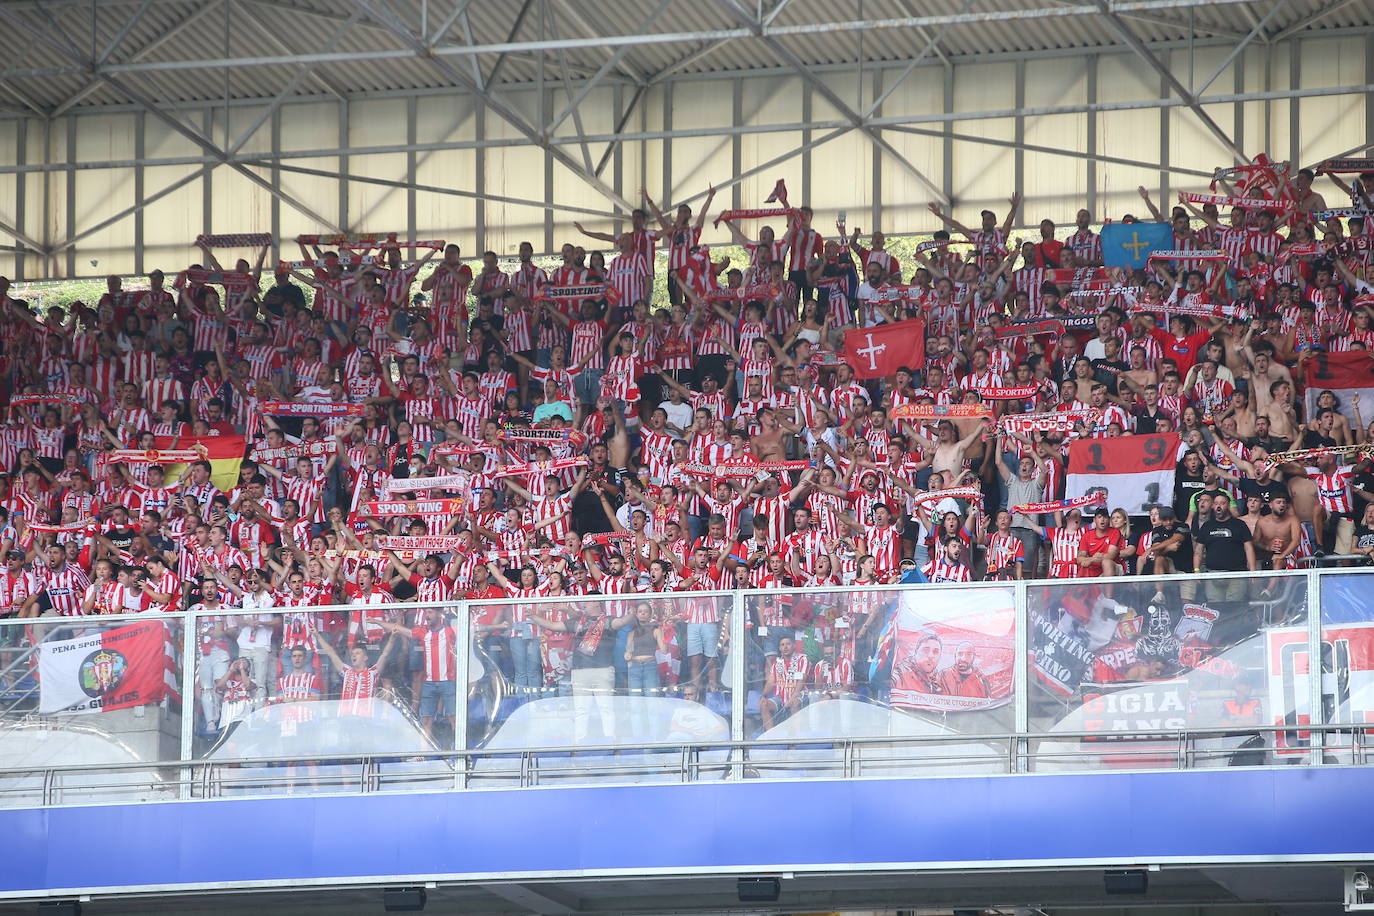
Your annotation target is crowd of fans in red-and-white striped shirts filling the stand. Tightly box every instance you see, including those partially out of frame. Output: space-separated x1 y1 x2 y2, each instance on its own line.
0 165 1374 728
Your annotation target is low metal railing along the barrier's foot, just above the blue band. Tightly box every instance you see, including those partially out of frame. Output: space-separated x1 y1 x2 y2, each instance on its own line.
0 725 1374 806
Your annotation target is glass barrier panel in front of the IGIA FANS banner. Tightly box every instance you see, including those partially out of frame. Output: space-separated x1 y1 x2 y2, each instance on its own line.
1026 573 1311 772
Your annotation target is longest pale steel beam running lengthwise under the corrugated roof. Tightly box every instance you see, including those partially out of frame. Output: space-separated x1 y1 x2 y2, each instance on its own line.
0 0 1254 82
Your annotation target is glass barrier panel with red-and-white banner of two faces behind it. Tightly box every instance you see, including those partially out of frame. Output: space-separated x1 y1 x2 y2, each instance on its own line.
745 585 1018 776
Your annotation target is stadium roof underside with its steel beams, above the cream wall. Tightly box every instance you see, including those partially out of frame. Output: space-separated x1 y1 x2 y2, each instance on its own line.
0 0 1374 117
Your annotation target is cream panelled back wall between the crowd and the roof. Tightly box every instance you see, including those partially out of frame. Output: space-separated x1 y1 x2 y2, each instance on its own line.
0 36 1370 276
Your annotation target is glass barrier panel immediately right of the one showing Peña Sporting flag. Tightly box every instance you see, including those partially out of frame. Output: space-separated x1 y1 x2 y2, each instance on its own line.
194 604 460 795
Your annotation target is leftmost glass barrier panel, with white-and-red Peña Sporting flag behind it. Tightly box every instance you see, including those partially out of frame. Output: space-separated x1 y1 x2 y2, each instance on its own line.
0 614 183 806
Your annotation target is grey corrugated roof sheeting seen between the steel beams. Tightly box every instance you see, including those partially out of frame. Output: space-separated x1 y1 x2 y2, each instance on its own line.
8 0 1374 108
